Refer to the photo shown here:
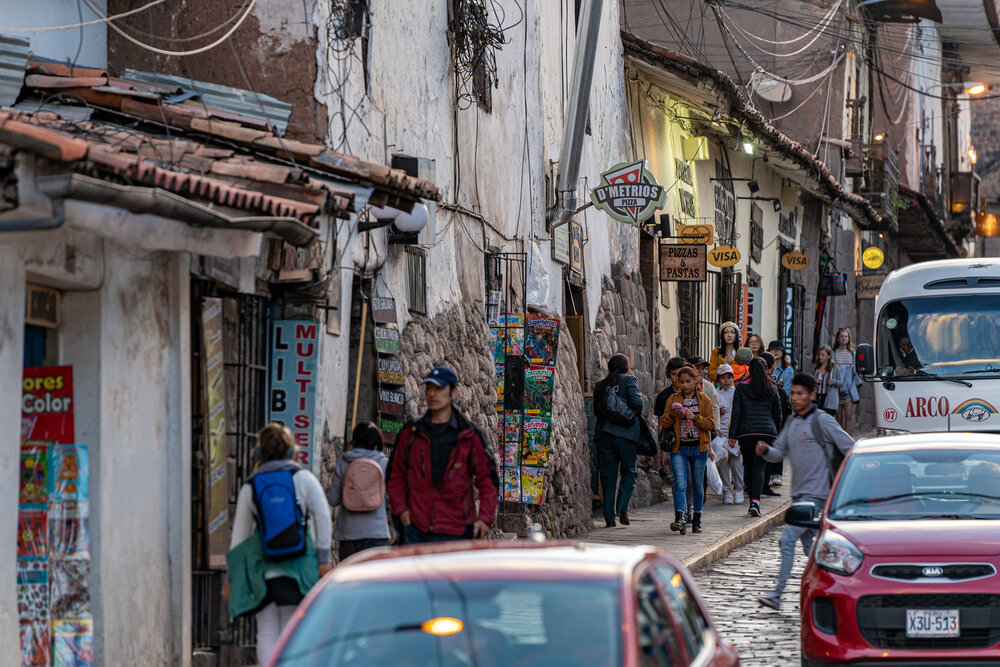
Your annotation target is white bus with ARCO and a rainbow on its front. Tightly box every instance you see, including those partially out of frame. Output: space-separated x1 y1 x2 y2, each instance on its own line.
857 258 1000 435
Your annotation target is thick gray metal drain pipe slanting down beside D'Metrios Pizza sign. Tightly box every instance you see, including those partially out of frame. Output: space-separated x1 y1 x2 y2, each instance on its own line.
549 0 604 227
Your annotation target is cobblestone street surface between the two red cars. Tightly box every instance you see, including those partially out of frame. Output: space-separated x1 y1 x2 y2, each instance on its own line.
695 527 806 667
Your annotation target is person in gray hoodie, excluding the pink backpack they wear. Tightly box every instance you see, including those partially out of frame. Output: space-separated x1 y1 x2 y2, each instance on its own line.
326 422 389 561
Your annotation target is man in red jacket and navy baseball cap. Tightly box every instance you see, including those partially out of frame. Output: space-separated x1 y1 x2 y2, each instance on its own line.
387 366 500 544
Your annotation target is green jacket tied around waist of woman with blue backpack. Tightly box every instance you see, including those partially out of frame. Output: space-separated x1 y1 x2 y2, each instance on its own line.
226 531 319 618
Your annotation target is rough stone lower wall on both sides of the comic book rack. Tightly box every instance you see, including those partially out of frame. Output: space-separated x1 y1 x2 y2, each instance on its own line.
401 302 590 537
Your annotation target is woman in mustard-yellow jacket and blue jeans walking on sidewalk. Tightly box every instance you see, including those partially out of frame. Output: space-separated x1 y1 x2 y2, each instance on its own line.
660 366 715 535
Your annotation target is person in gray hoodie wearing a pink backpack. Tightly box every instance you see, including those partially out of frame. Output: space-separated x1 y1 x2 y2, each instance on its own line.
326 422 389 560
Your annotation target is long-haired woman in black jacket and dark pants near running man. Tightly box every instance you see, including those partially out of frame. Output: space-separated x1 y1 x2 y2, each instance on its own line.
729 357 781 516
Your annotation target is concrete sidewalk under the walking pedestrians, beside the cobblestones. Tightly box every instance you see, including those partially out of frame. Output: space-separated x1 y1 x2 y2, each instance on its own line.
587 474 792 571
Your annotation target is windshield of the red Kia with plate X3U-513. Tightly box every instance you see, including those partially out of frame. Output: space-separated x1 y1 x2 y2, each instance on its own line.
829 449 1000 521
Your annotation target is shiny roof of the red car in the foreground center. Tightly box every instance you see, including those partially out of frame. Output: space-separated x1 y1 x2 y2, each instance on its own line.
331 540 681 581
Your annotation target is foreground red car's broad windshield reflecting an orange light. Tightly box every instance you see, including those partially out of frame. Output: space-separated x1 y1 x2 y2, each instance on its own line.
277 579 622 667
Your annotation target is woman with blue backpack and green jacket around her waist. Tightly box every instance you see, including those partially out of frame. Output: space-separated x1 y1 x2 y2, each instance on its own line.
223 422 331 665
